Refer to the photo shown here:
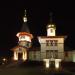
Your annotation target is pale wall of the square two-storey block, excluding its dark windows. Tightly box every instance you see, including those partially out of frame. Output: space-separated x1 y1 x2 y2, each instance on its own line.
39 37 64 59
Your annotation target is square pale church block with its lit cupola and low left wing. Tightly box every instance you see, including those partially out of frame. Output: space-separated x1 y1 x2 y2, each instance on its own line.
29 12 66 61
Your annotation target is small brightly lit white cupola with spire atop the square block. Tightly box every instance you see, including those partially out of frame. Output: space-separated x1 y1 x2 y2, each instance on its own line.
47 13 56 36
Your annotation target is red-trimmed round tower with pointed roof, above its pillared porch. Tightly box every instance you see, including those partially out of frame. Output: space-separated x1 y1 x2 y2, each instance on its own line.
16 10 32 47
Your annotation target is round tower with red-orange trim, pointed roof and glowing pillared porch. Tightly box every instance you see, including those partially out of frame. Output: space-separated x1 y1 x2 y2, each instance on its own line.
12 10 33 61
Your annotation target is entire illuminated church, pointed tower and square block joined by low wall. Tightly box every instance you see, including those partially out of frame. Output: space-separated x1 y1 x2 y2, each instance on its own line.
11 10 66 61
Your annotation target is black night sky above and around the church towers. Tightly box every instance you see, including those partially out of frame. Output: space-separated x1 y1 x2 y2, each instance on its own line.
0 0 75 53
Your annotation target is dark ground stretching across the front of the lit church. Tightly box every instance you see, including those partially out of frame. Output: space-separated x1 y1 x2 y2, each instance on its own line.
0 60 75 75
